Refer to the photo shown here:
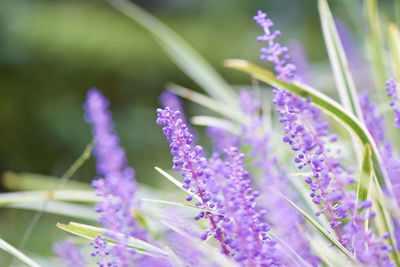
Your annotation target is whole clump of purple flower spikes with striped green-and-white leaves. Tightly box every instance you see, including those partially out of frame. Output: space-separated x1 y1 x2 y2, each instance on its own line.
3 0 400 266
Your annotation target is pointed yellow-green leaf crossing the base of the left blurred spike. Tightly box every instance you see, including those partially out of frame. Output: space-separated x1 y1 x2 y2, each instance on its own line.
57 222 167 257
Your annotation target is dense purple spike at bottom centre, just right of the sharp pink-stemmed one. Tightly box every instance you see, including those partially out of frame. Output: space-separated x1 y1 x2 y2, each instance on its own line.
211 147 282 266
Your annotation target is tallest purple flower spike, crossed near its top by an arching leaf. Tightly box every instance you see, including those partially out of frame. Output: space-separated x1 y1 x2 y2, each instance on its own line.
255 11 391 265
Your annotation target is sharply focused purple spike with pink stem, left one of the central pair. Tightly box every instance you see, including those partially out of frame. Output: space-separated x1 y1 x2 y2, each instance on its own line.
157 107 229 255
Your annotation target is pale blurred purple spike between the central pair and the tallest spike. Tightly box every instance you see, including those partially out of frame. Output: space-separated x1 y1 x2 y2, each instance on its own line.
239 90 321 266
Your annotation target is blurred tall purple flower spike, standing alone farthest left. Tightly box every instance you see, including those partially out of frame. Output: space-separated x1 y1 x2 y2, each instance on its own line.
84 88 146 266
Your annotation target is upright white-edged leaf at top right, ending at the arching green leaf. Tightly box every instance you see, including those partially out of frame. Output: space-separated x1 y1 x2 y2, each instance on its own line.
318 0 363 121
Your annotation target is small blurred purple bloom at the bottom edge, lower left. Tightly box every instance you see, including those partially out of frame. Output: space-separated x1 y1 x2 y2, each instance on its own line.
53 241 86 267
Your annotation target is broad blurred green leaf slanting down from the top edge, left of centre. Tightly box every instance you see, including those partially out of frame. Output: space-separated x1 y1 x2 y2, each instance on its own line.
107 0 237 106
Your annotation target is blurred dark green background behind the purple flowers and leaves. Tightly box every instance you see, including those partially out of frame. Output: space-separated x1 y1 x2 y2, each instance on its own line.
0 0 395 266
